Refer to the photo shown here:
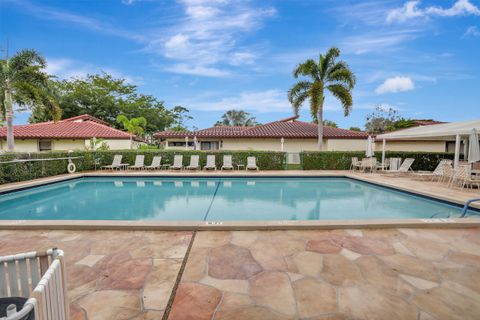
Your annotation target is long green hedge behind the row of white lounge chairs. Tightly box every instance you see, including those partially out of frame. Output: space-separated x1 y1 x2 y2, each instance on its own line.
0 150 286 184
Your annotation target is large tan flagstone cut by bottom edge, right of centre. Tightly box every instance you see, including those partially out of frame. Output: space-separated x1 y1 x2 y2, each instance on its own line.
338 285 417 320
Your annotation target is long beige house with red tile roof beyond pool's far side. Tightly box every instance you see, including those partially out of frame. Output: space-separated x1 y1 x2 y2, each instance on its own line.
154 116 452 153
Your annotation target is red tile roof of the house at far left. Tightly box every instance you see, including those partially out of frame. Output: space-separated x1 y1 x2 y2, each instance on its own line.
0 114 140 140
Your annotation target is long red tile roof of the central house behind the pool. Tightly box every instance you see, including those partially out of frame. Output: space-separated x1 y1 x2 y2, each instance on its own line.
154 116 368 139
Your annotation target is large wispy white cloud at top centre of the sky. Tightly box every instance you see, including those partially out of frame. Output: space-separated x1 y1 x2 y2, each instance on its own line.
146 0 276 77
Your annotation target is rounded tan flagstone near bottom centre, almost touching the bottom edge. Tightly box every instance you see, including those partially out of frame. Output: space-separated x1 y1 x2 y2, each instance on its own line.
250 271 296 316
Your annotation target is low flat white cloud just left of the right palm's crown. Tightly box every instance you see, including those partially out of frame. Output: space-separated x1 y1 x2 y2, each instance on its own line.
179 89 292 113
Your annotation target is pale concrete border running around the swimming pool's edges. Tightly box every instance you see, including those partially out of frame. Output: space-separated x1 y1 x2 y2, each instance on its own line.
0 170 480 231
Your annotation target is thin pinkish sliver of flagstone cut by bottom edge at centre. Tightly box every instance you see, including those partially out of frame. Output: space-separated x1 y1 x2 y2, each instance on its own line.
215 306 295 320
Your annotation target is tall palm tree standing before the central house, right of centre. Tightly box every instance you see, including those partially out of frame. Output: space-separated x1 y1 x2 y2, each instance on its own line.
288 48 355 150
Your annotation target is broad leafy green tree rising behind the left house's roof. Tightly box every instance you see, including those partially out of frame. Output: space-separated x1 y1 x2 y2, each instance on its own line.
30 72 179 135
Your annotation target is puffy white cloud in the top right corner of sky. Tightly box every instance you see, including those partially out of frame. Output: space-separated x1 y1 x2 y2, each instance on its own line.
386 0 480 23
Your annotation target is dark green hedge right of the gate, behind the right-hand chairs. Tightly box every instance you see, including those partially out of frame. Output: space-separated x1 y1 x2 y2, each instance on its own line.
300 151 454 171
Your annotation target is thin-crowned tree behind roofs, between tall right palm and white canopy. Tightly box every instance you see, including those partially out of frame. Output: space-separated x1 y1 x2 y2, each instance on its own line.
365 105 415 134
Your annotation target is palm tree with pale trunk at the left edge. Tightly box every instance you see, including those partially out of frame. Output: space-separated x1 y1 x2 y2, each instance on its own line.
0 50 62 151
